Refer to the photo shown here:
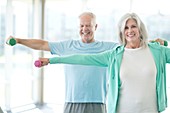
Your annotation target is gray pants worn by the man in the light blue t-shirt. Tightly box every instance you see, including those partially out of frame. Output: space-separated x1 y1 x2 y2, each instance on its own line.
64 103 106 113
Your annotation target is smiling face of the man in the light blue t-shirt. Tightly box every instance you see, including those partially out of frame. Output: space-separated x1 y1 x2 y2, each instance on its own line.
79 15 97 43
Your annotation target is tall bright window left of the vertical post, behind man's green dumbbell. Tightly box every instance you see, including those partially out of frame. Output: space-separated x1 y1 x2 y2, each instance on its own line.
0 0 34 110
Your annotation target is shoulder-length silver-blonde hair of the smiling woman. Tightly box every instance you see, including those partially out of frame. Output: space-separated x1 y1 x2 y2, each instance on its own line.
118 13 148 46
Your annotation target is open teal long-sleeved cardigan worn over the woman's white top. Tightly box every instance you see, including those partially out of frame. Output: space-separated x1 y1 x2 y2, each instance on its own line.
49 43 170 113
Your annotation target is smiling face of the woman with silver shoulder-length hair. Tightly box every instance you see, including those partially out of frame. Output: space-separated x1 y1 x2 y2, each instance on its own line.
124 19 140 44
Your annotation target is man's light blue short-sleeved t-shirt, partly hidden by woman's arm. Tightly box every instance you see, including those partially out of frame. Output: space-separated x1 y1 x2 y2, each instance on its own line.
49 40 118 103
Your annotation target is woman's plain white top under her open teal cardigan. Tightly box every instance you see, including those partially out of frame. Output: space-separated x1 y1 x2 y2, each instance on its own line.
116 47 158 113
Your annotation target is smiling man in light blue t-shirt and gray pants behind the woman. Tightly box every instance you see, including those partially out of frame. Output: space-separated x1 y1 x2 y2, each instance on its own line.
7 12 167 113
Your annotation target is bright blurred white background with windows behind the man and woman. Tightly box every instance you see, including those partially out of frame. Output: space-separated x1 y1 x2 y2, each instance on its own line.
0 0 170 113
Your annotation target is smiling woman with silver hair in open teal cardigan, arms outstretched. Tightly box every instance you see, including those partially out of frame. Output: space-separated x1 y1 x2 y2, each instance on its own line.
37 13 170 113
